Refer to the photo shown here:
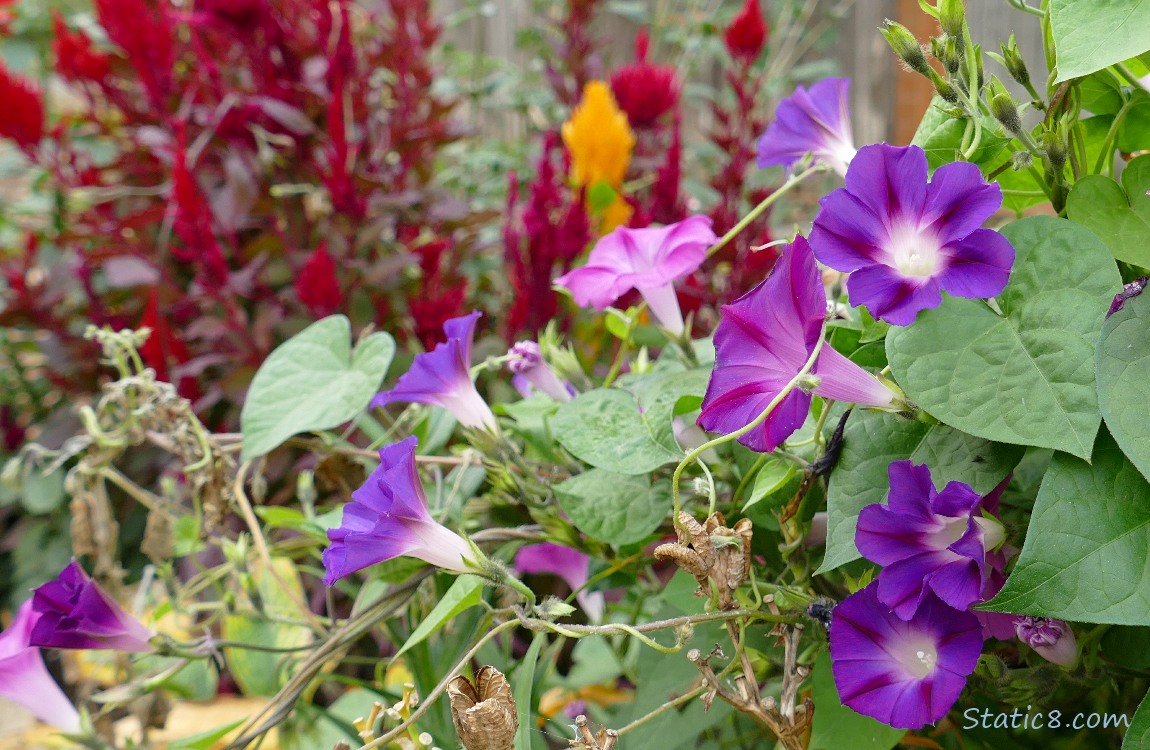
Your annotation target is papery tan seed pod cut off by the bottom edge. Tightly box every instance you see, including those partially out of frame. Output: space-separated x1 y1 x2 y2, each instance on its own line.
447 666 519 750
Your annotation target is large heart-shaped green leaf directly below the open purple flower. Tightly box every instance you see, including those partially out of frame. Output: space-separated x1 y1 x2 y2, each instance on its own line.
887 216 1121 458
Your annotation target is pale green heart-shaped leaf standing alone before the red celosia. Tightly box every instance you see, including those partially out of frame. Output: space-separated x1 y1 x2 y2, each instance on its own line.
239 315 396 461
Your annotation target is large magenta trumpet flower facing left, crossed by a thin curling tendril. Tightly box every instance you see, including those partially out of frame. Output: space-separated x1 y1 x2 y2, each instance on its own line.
698 235 896 453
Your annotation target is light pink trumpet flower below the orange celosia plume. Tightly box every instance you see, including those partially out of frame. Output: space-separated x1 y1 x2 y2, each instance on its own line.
555 216 719 336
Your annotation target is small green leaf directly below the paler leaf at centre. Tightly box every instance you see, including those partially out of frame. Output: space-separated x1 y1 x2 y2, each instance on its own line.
553 469 672 544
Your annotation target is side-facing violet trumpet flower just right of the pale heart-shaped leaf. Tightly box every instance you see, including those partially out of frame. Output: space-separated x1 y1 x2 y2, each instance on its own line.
371 311 498 431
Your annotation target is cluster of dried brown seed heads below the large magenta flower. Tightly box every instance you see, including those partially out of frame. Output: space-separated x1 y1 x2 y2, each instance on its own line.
654 512 751 610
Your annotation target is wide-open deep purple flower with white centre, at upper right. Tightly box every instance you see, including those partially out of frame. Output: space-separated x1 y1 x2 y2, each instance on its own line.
811 144 1014 326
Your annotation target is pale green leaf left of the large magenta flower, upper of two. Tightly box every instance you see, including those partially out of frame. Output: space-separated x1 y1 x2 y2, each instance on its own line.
551 388 682 474
